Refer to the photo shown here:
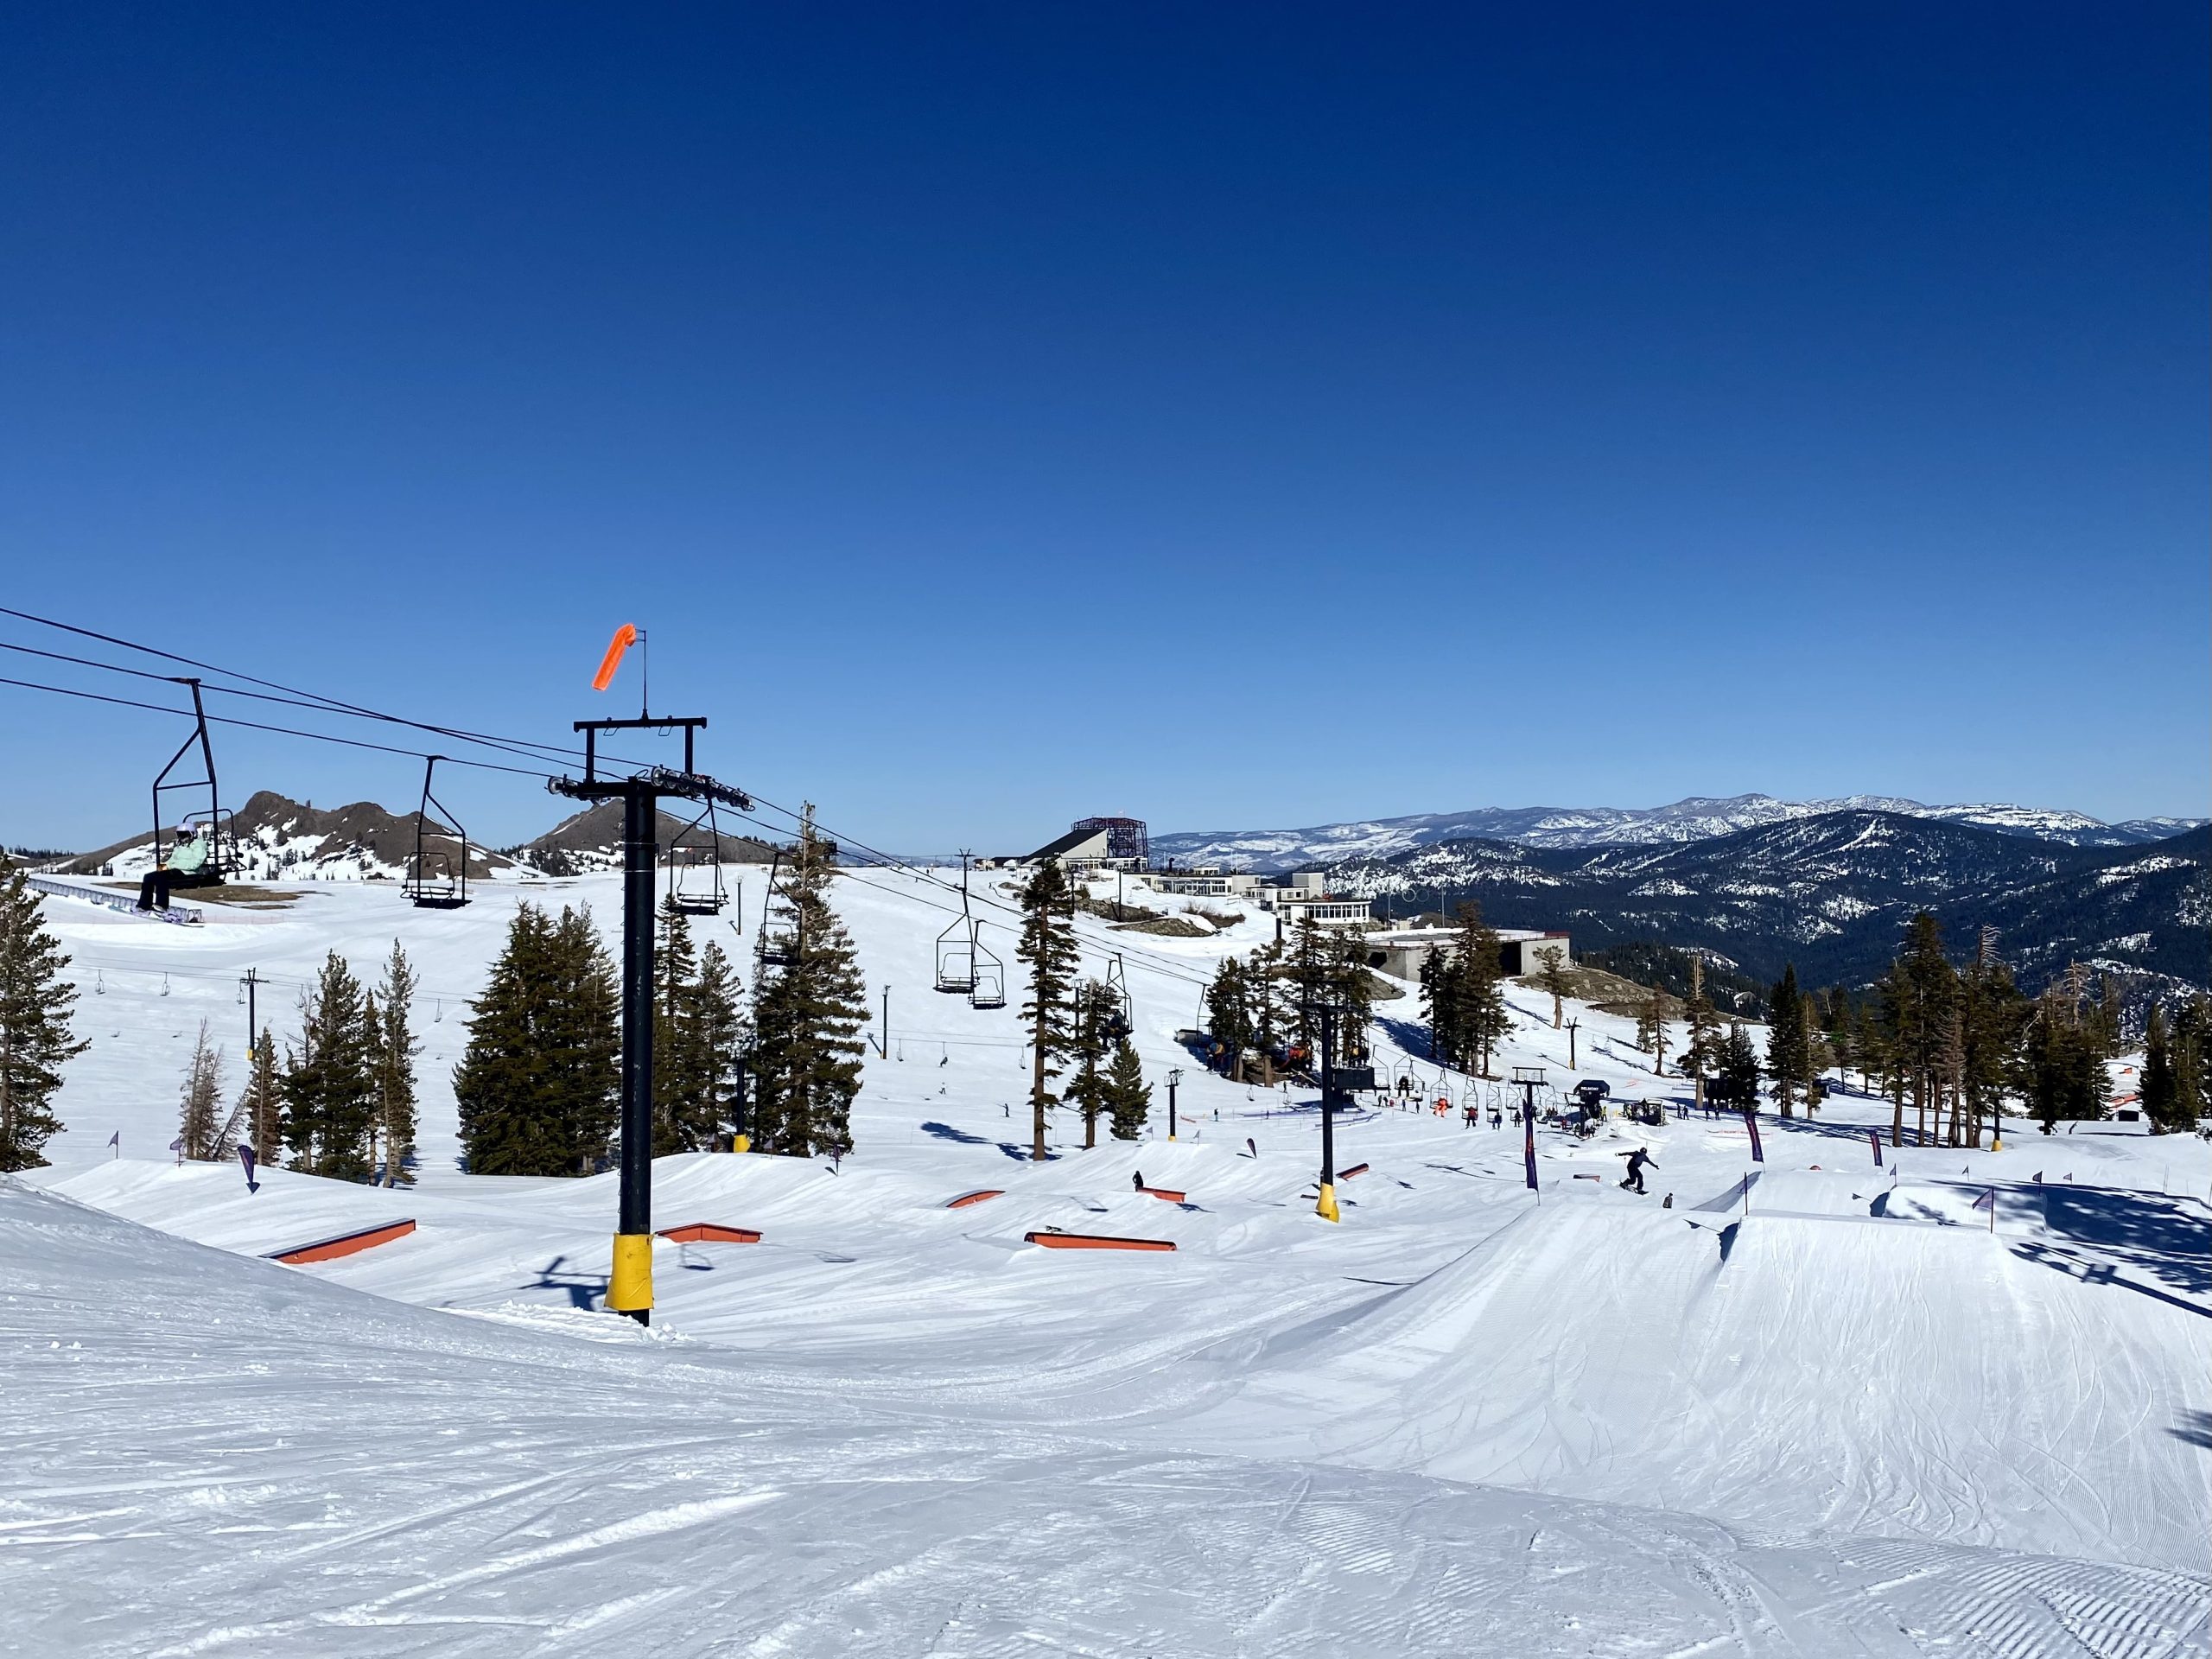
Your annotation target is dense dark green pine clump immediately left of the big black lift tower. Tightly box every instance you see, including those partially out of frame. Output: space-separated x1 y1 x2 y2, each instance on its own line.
454 902 621 1174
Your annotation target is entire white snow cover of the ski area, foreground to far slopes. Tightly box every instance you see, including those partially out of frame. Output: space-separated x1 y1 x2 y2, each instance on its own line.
0 872 2212 1659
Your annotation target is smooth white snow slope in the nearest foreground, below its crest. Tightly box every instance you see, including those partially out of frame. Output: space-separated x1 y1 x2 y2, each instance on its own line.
21 1181 2203 1659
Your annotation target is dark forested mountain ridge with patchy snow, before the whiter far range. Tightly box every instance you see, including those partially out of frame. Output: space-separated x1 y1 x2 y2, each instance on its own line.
1327 810 2212 988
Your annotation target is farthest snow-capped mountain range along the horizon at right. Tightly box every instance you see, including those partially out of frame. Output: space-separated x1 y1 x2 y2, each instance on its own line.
1153 794 2205 872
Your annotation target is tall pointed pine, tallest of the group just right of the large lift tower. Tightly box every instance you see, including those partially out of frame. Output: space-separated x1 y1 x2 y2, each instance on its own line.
752 807 868 1157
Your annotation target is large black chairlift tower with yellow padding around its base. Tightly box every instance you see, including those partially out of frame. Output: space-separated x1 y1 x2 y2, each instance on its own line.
546 708 752 1325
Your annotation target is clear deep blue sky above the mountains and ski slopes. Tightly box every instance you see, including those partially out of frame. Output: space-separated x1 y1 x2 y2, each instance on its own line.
0 4 2212 849
